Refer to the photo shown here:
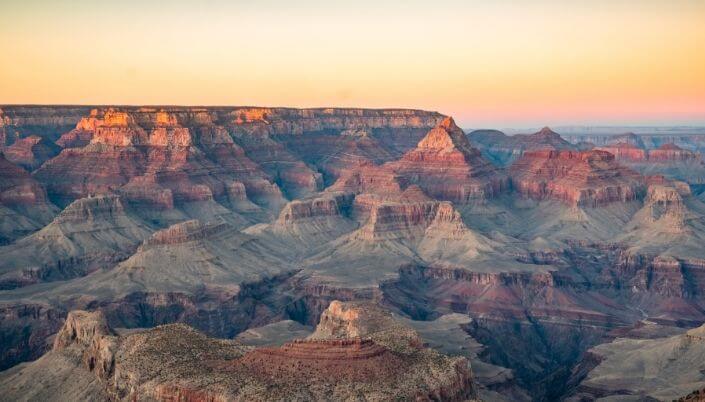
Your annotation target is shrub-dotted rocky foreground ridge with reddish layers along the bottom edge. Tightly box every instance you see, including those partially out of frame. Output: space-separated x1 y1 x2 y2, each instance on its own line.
0 304 475 400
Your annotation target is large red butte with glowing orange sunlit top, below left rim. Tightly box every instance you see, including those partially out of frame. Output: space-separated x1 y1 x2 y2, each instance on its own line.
36 109 276 209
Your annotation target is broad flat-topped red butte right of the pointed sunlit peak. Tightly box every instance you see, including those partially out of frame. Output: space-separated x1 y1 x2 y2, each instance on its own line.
510 151 643 207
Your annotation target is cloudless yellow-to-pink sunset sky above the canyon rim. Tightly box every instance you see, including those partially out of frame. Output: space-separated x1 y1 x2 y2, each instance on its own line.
0 0 705 127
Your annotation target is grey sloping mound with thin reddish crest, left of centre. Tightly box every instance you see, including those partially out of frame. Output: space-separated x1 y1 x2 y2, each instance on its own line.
64 220 293 303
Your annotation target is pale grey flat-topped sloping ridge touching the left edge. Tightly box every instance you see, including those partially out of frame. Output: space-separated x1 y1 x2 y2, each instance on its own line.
0 196 151 289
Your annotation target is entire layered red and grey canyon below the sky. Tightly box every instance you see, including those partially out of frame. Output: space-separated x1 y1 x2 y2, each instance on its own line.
0 106 705 401
